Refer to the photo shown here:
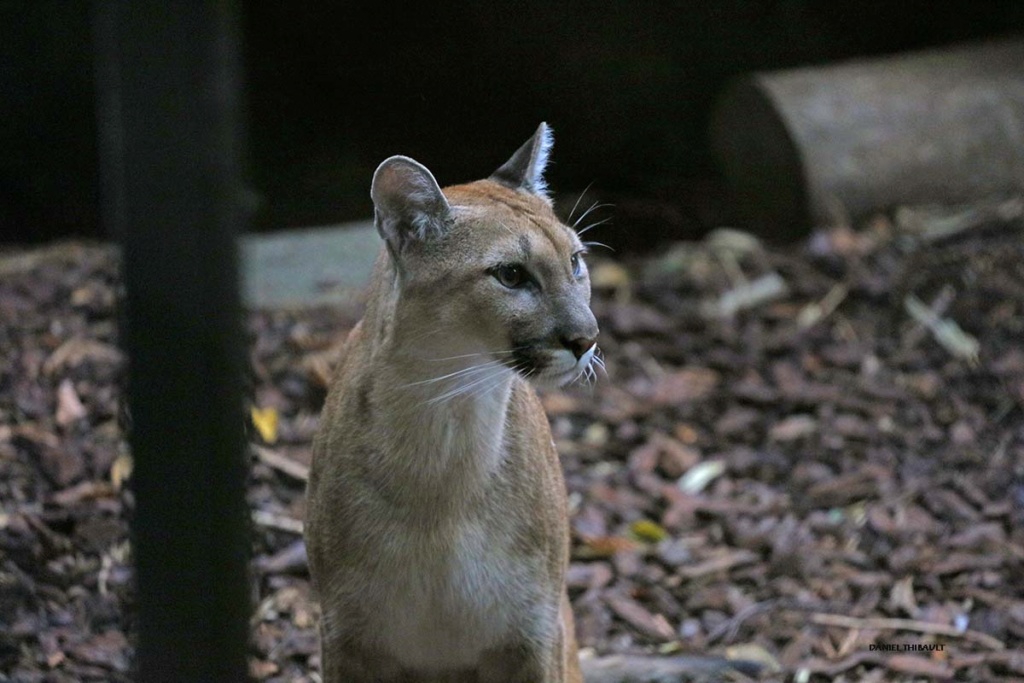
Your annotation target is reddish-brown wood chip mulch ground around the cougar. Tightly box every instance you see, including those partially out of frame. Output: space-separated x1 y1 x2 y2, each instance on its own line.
0 210 1024 683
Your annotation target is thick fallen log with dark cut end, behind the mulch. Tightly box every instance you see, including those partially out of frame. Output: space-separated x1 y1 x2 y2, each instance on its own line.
711 38 1024 237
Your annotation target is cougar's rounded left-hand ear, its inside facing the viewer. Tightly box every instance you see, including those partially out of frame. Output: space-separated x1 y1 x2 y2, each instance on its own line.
370 157 451 255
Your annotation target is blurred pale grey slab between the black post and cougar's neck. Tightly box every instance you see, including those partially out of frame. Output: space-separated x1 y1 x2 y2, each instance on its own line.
240 220 381 308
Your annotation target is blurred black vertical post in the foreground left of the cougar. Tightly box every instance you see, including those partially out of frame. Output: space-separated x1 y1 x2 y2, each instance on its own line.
95 0 250 683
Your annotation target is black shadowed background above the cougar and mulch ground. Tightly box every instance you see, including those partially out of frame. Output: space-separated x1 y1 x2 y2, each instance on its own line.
6 0 1024 243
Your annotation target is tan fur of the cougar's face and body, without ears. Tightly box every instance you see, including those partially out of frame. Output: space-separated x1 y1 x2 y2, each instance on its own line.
306 145 597 683
